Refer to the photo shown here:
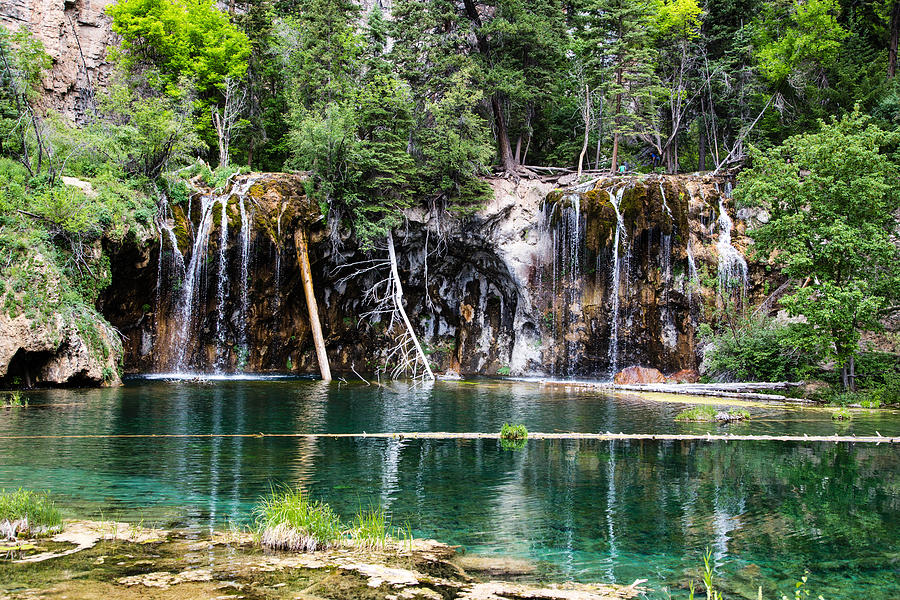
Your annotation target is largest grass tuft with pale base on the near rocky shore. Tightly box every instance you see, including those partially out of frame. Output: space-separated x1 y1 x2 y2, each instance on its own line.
254 488 343 552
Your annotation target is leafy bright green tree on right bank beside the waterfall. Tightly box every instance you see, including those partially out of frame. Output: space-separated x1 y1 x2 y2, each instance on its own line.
736 111 900 388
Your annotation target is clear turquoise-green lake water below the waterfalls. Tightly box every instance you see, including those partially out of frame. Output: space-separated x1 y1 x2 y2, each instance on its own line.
0 380 900 600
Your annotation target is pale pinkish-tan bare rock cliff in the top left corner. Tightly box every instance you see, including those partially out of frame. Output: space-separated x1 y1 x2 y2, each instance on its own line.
0 0 113 122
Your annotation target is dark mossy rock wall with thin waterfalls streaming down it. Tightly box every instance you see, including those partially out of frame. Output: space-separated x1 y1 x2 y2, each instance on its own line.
101 174 756 377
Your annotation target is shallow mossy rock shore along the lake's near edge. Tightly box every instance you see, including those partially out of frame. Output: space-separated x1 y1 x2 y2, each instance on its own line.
0 521 644 600
